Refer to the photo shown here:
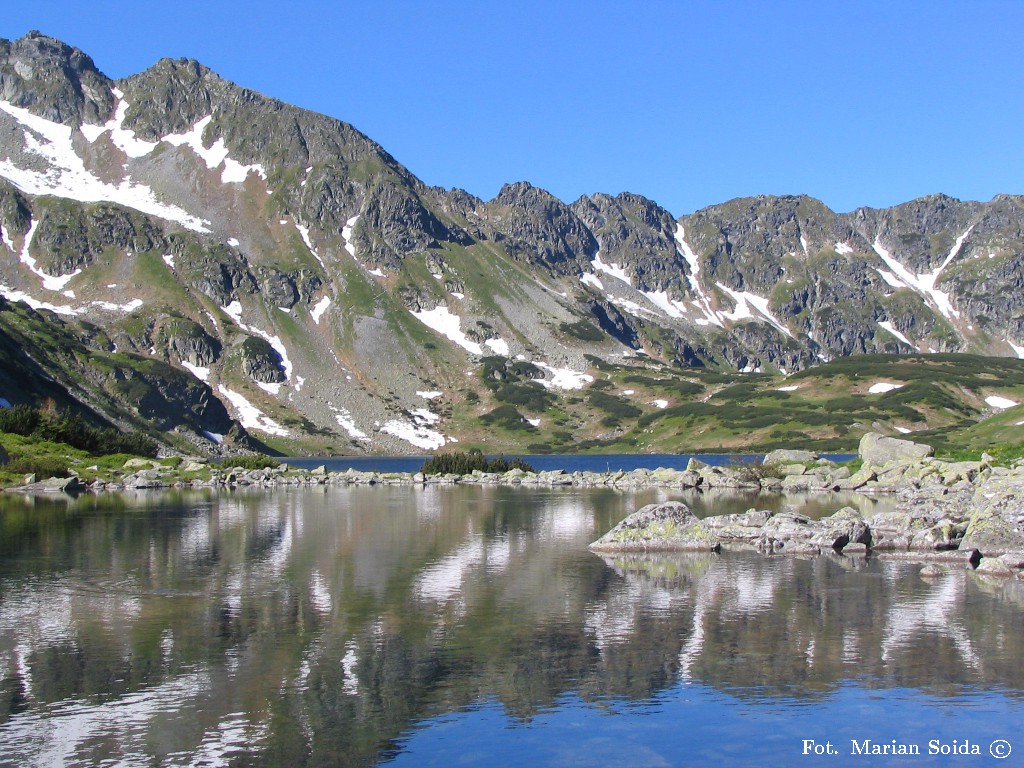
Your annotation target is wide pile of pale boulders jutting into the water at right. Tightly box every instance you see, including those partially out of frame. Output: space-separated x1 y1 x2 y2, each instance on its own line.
591 434 1024 577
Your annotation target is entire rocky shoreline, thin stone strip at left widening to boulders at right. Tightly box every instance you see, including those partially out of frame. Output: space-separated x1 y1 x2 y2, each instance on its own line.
6 433 1024 574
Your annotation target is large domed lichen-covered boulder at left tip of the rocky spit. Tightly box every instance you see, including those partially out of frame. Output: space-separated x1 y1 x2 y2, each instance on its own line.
590 502 721 552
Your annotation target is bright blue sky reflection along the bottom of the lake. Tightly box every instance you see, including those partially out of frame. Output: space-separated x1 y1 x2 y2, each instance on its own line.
387 683 1024 768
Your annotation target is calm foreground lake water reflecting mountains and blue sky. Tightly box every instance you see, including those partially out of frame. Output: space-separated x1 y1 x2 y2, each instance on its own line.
0 486 1024 768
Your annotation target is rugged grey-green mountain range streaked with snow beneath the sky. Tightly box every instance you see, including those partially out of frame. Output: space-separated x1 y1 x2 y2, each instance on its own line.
0 33 1024 453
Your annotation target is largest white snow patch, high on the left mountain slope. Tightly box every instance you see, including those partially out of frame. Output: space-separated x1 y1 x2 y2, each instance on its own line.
0 101 210 233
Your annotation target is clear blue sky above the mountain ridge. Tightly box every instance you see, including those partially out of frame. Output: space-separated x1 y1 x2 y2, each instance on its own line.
0 0 1024 216
